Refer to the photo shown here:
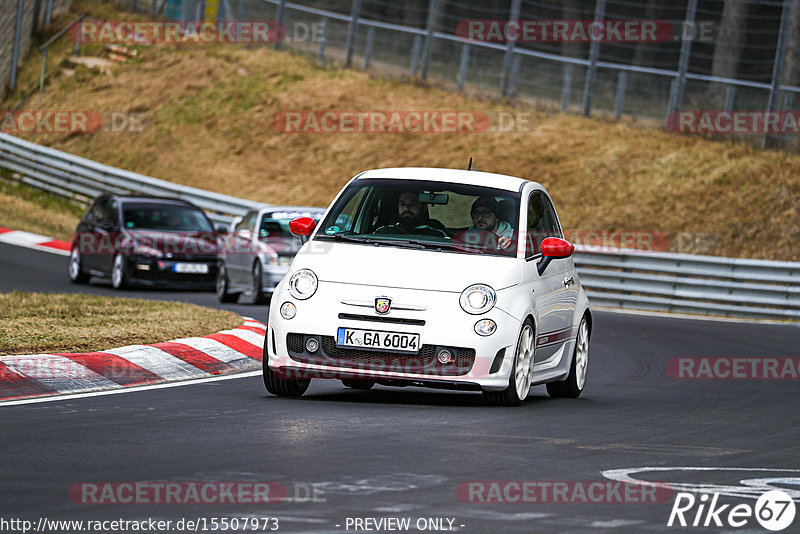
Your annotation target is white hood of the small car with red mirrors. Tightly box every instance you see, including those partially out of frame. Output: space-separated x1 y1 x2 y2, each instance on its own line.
291 240 522 293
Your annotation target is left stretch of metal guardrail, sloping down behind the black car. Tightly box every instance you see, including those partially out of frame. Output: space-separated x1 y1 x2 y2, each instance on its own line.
0 134 264 228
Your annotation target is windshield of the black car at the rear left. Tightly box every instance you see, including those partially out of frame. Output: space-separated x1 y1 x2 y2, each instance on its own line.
122 203 214 232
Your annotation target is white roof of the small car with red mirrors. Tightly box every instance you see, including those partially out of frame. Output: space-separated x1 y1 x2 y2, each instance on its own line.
358 167 541 192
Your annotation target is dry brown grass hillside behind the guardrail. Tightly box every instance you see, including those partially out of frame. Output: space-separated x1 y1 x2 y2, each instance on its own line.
3 2 800 261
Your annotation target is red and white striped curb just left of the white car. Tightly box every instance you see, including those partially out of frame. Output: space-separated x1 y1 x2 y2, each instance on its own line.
0 318 266 402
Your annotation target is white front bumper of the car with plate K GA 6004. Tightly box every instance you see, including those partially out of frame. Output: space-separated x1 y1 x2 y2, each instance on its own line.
267 282 521 390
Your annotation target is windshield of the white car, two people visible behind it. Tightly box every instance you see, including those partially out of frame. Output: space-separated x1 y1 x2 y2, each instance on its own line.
315 179 520 256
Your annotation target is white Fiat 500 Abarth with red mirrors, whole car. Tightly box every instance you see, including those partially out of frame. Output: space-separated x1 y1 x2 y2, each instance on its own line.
263 168 592 405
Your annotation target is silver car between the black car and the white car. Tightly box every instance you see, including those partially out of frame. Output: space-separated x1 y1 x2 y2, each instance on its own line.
216 206 325 304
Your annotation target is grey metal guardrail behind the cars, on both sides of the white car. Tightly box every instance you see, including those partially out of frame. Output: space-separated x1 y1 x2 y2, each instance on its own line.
0 134 800 320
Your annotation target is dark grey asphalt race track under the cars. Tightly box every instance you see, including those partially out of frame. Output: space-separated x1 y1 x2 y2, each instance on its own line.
0 245 800 533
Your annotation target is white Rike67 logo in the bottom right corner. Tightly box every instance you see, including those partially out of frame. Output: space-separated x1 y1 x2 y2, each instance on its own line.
667 490 796 532
